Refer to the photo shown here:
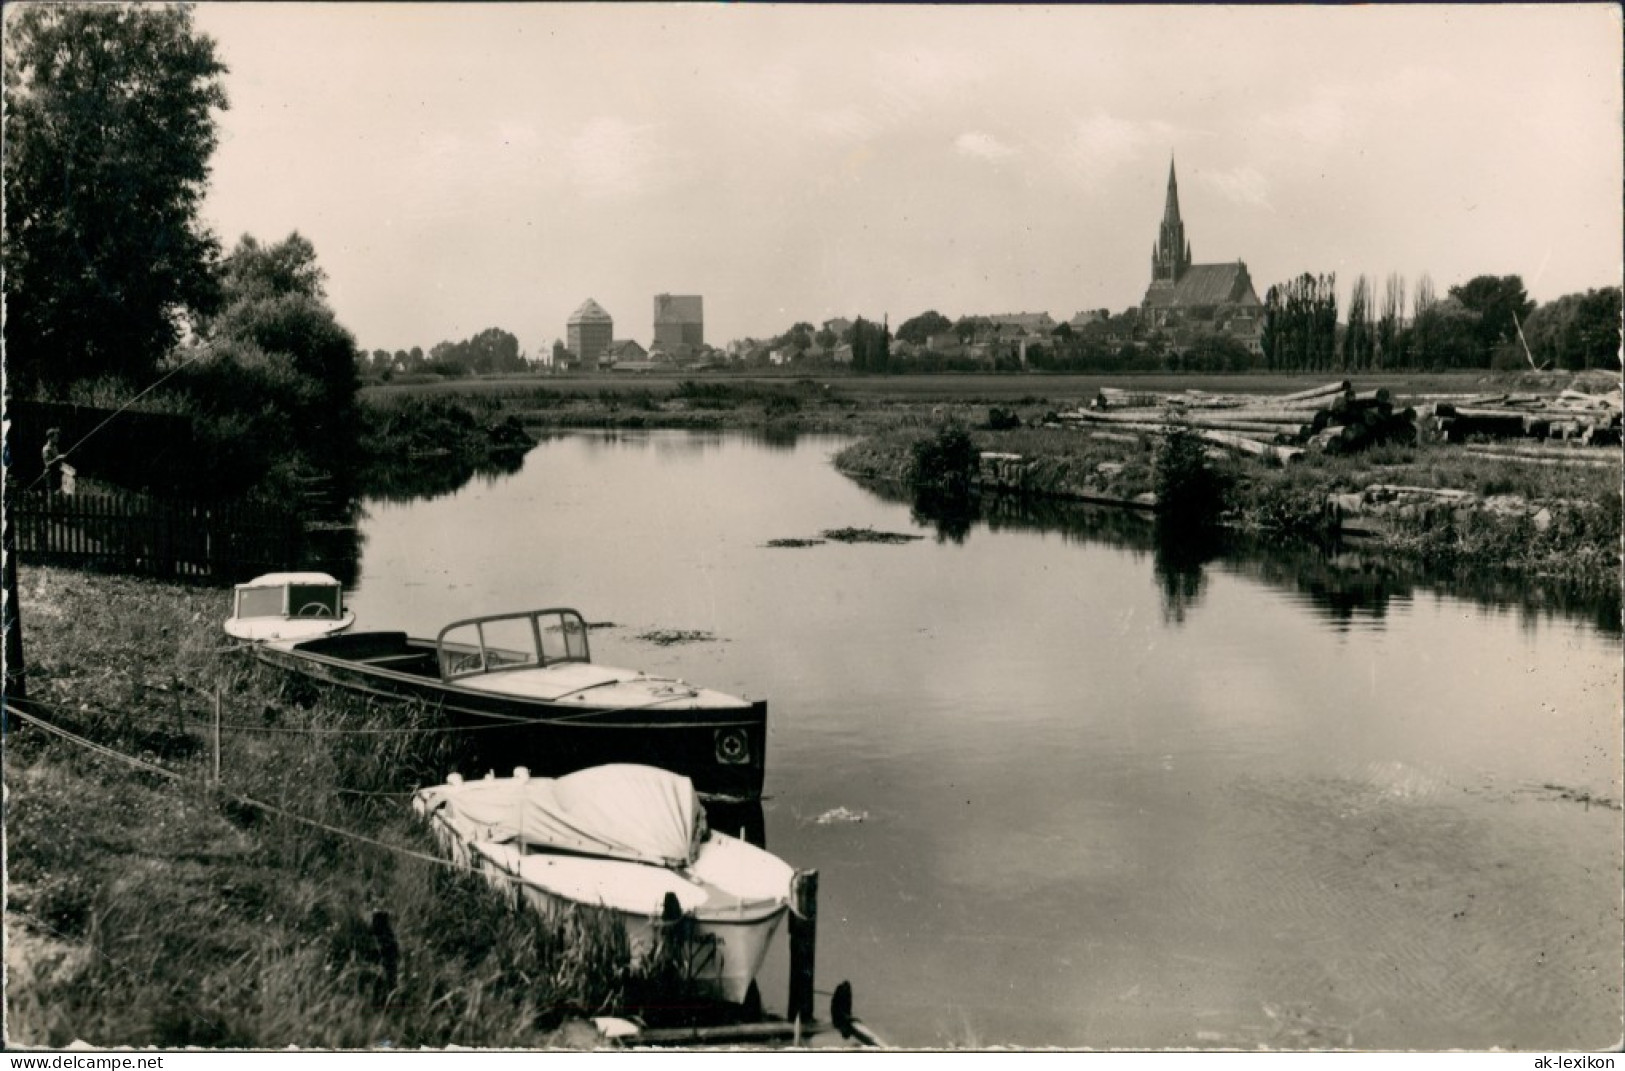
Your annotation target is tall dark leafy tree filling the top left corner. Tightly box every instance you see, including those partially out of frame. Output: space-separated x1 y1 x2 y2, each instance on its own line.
3 5 226 392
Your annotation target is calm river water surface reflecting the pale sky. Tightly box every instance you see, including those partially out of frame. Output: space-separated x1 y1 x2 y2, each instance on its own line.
353 432 1625 1048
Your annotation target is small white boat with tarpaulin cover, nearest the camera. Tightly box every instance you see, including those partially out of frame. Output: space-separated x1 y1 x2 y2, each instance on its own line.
413 764 795 1003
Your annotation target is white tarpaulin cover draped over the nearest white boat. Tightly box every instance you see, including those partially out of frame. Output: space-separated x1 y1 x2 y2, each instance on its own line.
416 764 705 866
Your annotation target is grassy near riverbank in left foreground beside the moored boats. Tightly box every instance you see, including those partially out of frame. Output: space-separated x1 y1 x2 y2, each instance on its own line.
5 567 708 1048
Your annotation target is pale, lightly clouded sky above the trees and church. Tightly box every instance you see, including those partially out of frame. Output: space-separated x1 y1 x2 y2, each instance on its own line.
184 3 1625 354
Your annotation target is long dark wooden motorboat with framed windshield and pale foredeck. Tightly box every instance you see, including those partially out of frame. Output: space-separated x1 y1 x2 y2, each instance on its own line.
254 608 767 801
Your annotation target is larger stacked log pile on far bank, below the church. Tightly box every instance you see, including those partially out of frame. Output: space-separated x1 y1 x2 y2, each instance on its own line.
1056 380 1415 465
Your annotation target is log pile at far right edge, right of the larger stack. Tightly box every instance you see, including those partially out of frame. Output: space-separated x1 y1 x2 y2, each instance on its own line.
1424 390 1620 447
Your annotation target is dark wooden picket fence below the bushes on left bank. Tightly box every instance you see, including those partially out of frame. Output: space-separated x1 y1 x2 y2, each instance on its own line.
7 491 304 583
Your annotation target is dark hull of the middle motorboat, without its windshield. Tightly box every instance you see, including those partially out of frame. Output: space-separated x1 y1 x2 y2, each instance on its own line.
254 632 767 801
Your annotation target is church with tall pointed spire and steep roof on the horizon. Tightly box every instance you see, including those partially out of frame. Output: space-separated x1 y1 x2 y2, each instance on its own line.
1139 156 1263 351
